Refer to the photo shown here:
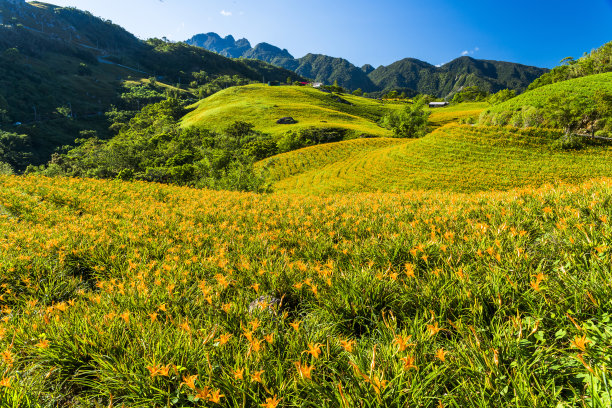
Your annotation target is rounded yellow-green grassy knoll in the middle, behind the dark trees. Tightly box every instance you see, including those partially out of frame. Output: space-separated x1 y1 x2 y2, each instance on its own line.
183 85 402 136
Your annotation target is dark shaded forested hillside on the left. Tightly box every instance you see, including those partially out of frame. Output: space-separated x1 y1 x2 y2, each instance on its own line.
0 0 299 170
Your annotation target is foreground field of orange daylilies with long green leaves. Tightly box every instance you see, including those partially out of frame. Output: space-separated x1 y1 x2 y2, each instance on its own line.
0 174 612 408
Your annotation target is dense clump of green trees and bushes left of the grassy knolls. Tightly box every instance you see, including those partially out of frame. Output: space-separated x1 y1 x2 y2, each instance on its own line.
42 99 277 191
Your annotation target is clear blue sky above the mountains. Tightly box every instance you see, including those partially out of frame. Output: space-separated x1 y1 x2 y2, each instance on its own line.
40 0 612 68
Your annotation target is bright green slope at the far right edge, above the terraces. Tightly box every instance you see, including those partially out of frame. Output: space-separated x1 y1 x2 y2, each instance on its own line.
489 72 612 113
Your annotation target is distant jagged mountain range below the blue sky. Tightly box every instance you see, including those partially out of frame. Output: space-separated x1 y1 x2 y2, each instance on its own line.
186 33 549 97
